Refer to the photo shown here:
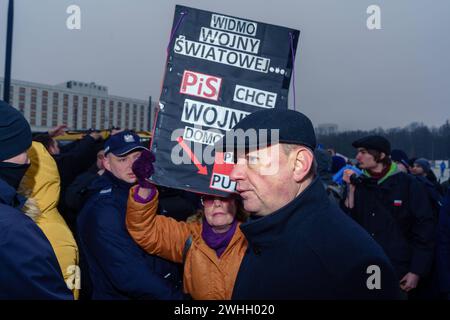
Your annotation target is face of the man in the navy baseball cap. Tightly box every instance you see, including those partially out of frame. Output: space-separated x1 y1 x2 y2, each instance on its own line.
103 151 142 183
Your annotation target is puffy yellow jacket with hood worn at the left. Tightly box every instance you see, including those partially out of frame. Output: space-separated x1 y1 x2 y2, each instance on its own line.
19 141 80 299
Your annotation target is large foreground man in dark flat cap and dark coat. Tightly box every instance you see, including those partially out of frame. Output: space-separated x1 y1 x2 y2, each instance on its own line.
216 110 399 299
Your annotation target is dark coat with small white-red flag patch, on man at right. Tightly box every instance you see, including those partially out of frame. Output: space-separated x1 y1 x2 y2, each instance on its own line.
348 166 435 279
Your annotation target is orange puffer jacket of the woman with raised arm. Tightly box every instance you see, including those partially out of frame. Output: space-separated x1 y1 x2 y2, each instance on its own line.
126 187 247 300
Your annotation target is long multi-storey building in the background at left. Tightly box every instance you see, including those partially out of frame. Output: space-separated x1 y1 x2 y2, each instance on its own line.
0 78 155 131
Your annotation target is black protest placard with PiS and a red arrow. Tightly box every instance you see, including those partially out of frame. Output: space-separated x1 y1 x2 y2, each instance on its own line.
151 6 300 195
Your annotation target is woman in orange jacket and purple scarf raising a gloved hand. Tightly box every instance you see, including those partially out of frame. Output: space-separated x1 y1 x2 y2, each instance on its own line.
126 151 247 300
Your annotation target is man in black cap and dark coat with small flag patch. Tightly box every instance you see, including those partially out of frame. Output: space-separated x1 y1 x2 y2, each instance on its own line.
344 136 435 297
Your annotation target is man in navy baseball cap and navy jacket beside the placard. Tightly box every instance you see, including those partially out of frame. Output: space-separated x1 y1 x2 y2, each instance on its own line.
77 131 184 300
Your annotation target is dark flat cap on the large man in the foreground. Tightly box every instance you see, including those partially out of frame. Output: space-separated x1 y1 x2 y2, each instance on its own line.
215 109 316 152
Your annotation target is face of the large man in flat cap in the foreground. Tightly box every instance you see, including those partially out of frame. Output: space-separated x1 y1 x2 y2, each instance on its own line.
230 144 299 216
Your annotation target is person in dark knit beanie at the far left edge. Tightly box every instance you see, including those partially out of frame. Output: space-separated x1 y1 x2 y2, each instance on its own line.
0 101 73 300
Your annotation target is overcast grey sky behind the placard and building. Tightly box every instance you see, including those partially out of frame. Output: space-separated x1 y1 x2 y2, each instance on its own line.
0 0 450 129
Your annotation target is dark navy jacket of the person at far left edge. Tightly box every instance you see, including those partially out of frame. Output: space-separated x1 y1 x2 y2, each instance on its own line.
0 179 73 300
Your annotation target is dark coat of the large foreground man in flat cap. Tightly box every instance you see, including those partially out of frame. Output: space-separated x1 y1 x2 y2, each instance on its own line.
233 178 399 300
